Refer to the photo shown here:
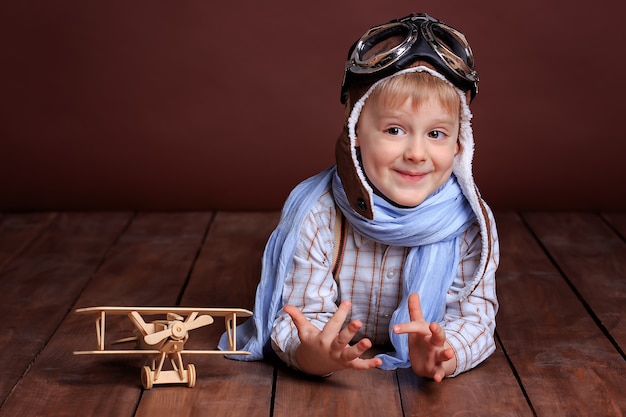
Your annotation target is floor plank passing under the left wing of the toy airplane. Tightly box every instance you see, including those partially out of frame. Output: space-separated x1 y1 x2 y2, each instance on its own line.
0 213 211 416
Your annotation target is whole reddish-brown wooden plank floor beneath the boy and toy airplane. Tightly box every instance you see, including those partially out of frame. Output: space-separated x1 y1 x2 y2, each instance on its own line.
0 212 626 417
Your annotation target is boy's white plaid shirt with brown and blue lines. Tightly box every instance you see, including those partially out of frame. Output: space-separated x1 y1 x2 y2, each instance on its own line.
271 188 498 375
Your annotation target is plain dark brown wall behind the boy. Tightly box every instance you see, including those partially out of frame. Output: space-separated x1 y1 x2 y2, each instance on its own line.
0 0 626 210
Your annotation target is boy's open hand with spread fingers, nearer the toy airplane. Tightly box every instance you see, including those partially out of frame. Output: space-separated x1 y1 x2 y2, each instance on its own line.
284 301 382 375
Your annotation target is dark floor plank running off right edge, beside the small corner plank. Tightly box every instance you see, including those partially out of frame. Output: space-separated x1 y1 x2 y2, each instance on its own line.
523 213 626 352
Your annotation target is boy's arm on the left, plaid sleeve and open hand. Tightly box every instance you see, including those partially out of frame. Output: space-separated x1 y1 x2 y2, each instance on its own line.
272 203 382 375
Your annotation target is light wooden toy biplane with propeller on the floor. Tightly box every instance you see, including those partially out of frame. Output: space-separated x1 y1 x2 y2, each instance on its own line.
74 307 252 389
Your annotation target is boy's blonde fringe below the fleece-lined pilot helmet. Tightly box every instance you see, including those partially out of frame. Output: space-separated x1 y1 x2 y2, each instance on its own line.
368 72 461 115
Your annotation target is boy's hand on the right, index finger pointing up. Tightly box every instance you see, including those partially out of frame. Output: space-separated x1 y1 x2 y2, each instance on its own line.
393 294 456 382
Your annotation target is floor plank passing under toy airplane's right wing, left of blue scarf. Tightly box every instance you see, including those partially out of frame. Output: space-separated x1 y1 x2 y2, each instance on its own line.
136 212 278 417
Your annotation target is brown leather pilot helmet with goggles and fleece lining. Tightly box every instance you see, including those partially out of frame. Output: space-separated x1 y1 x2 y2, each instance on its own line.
335 14 478 220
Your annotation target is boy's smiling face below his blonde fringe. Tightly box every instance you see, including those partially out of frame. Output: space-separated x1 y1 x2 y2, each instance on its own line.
356 94 460 207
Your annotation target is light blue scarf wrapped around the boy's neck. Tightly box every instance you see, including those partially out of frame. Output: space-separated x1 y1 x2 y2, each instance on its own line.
218 167 475 369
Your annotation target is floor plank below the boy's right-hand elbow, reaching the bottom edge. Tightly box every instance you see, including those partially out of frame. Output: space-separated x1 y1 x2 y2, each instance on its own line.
398 340 534 417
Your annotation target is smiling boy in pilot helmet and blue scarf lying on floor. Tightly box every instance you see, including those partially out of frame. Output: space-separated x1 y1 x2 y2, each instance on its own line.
220 14 499 382
